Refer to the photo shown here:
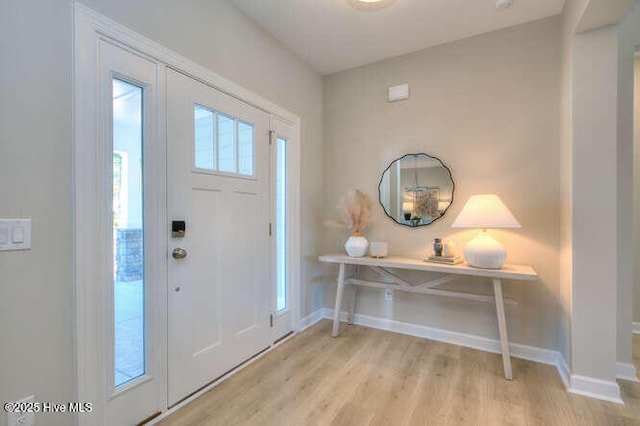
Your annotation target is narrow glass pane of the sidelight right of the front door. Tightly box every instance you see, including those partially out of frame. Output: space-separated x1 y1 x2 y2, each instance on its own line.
276 138 289 311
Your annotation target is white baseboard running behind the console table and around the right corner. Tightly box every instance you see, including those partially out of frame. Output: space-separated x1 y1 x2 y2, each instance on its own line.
322 308 629 404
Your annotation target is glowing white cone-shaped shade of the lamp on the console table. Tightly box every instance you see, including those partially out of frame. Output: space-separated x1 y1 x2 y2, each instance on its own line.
451 194 521 229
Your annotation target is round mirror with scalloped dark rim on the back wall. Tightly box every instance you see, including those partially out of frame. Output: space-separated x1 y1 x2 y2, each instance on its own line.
378 154 455 227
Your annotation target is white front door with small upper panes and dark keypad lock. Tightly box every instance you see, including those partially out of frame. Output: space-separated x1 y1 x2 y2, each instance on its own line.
167 70 272 406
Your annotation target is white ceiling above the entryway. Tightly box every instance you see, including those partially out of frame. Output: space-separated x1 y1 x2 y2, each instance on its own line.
231 0 565 74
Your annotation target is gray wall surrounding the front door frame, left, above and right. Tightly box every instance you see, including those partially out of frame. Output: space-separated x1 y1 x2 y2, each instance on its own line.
0 0 323 426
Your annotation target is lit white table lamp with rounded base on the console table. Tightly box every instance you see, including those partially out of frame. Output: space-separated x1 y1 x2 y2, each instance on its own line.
451 194 521 269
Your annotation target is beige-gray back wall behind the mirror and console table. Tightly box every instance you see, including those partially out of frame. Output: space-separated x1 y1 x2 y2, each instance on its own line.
324 17 561 350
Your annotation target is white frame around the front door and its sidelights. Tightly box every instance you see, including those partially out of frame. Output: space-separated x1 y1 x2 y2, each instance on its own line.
73 3 301 426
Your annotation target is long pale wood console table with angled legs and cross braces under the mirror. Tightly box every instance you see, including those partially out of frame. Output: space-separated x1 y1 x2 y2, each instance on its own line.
319 254 538 380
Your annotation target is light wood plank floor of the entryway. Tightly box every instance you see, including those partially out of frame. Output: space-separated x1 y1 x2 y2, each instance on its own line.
160 321 640 426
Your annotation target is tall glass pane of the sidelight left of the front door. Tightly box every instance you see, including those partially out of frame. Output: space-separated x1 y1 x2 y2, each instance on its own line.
112 79 145 386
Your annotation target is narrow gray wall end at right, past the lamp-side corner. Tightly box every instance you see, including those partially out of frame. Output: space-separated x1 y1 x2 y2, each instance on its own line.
571 26 619 380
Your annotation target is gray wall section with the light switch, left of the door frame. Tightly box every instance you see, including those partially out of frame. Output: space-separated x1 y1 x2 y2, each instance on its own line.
0 0 74 426
